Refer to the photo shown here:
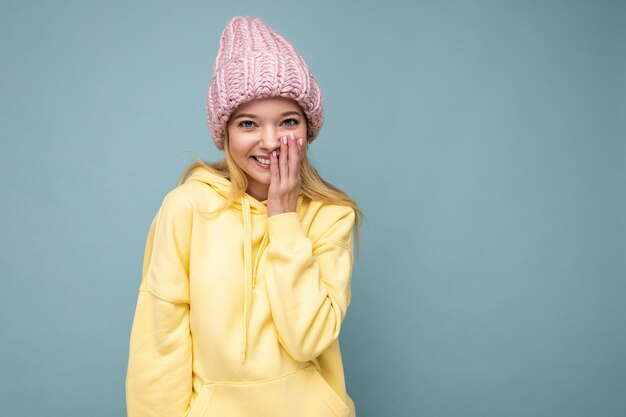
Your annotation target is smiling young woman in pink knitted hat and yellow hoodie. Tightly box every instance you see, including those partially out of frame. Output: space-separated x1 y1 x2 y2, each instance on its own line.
126 17 362 417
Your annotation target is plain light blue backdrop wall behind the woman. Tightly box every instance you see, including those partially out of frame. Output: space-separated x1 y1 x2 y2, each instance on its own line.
0 0 626 417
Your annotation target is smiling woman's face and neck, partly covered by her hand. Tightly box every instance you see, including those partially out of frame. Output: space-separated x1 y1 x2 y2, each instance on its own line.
227 97 307 201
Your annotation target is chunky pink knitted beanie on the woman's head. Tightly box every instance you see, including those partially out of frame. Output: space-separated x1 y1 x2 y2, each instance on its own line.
206 16 324 149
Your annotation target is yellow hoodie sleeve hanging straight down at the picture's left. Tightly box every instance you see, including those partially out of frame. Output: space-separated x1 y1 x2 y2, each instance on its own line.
126 193 193 417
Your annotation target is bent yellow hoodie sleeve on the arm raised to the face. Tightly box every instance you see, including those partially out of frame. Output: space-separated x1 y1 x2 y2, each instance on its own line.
266 206 355 361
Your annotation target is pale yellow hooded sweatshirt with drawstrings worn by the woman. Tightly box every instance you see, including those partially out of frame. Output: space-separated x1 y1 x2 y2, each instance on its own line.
126 168 355 417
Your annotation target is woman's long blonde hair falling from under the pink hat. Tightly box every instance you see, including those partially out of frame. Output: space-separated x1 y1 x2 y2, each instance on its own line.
178 131 364 251
